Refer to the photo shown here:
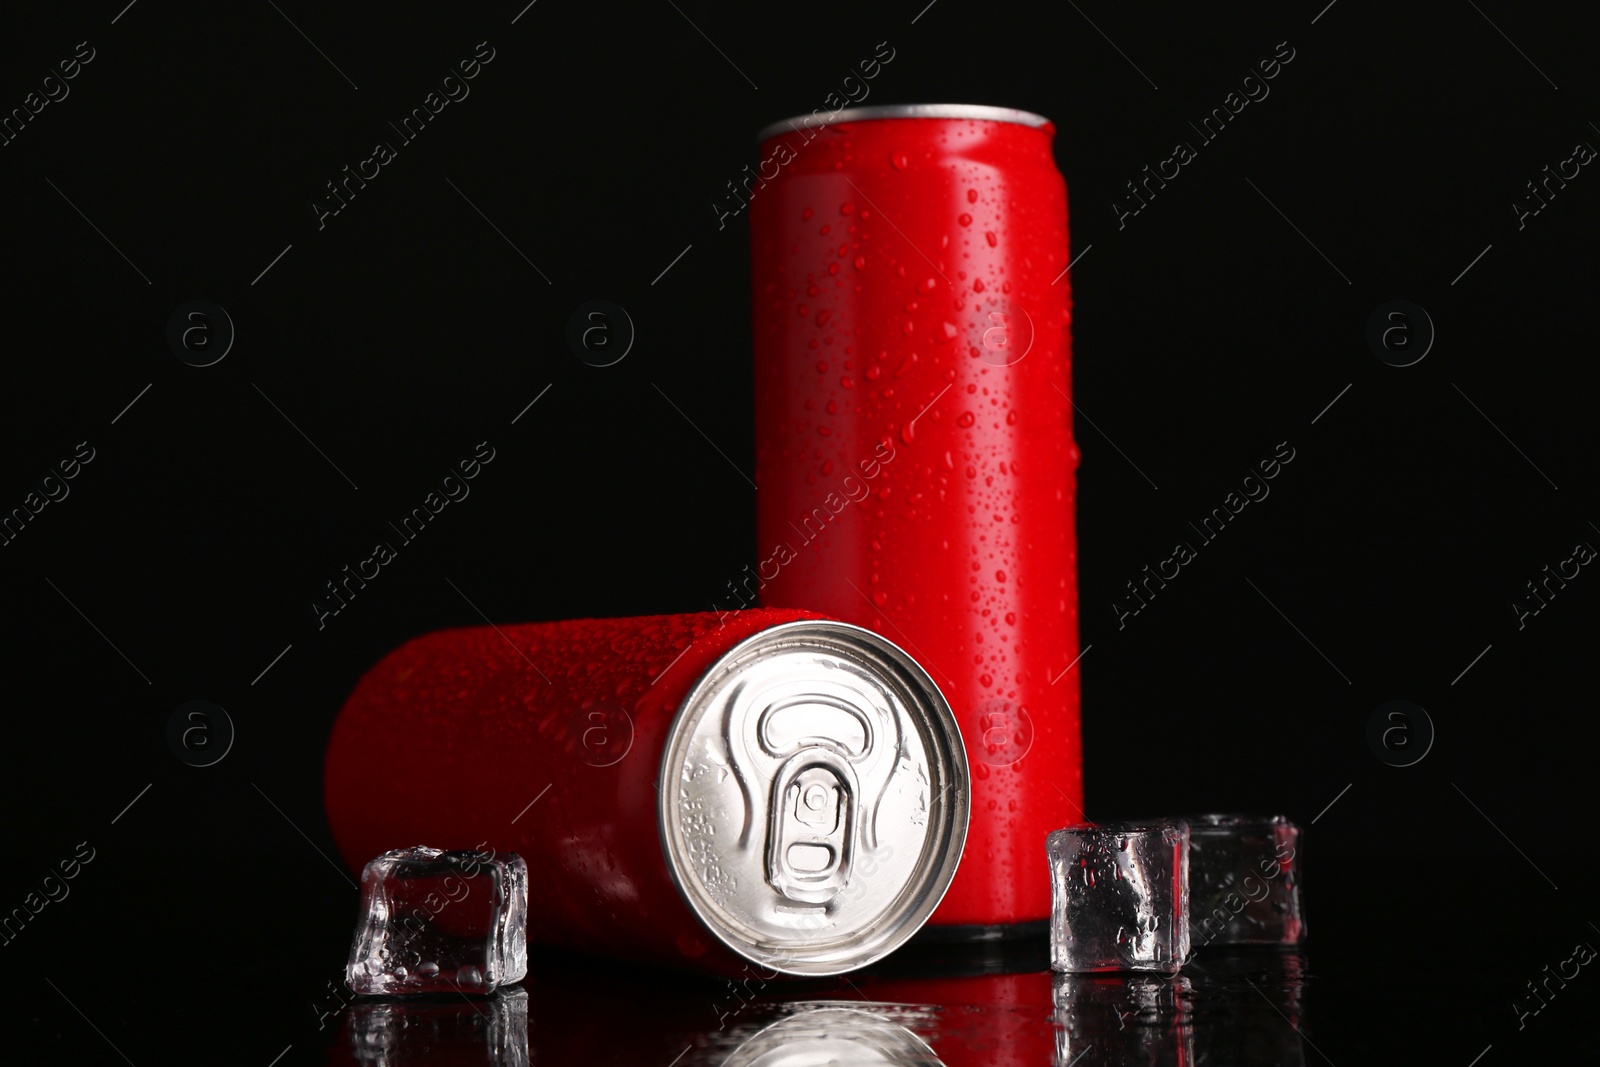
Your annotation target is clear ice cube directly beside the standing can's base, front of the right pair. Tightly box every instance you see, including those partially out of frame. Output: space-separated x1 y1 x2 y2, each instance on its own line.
1046 821 1189 974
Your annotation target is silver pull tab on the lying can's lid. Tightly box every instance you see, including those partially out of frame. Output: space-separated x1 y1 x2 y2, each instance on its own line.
766 749 856 904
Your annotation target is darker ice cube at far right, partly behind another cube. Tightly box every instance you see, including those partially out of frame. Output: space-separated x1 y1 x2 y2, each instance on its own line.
1184 814 1306 949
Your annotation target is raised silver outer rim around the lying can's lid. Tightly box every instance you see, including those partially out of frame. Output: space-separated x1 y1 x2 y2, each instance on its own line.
656 619 971 977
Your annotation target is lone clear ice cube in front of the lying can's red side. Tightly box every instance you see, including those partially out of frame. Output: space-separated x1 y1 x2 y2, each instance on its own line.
344 846 528 993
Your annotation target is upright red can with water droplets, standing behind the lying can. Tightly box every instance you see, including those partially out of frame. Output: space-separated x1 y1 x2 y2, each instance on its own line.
749 106 1083 933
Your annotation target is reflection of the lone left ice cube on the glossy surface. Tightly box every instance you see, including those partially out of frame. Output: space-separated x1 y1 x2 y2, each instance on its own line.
328 985 528 1067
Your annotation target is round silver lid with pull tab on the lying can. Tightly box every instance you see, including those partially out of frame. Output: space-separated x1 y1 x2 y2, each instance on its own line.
659 619 971 976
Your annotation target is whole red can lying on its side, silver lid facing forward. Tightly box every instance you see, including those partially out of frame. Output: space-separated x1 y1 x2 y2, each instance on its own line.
325 609 970 977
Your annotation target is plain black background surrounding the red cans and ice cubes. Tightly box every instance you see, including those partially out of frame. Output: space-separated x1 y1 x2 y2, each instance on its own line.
0 0 1600 1067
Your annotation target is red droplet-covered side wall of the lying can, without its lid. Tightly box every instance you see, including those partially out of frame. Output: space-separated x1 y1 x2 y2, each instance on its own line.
323 609 819 973
